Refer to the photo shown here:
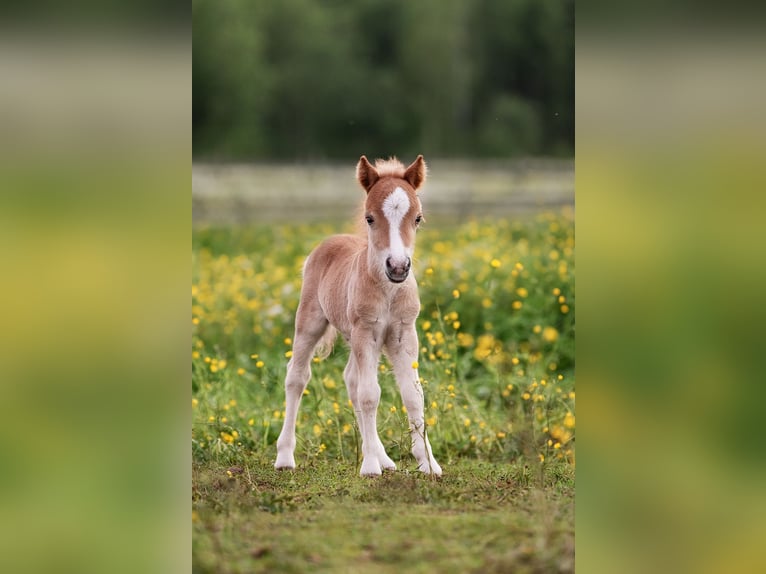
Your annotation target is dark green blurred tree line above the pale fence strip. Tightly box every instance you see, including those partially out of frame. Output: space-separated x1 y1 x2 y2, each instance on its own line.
192 0 574 160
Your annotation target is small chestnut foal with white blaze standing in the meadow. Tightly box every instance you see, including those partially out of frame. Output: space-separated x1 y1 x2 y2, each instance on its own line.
274 155 442 476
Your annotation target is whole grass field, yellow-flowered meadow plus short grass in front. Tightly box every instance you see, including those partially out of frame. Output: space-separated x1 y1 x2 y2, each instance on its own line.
192 210 575 572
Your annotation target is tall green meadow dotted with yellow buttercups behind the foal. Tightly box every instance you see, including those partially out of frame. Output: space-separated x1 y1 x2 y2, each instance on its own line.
192 212 575 467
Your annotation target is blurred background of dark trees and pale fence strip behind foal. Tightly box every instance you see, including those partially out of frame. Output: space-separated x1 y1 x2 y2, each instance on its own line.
192 0 574 223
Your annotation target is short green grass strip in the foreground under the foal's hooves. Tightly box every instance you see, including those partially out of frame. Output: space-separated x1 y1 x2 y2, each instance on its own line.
192 459 574 572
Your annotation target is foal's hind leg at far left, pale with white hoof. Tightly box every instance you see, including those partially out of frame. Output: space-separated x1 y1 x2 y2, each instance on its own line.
274 302 328 469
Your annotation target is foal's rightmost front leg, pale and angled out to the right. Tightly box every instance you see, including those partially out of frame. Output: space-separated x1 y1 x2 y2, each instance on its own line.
386 323 442 476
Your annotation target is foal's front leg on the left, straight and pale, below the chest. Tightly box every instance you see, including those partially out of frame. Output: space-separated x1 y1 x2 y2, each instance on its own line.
347 328 396 476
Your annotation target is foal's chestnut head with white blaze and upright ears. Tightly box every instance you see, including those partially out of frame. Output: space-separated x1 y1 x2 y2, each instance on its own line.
356 155 426 283
